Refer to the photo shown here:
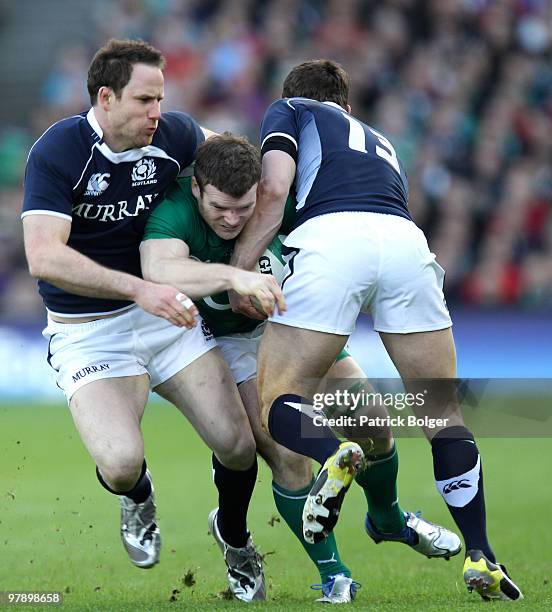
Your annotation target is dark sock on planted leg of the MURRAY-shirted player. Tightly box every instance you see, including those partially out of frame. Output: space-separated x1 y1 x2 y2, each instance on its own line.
212 453 257 548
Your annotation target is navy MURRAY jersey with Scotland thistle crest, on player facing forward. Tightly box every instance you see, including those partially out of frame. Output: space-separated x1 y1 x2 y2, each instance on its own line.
22 109 204 316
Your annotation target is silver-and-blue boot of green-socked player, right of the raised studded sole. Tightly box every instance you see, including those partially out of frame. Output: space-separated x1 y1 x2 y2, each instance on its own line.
364 512 462 561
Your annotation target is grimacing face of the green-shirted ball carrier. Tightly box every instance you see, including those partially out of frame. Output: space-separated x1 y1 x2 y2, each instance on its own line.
192 179 257 240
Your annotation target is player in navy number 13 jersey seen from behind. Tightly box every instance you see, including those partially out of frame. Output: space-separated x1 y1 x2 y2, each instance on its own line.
231 60 522 600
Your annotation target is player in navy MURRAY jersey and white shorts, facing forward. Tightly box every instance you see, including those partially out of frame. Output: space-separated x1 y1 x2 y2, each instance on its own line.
22 40 283 599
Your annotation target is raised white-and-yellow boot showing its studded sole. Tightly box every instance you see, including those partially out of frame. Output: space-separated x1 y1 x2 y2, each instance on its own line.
303 442 364 544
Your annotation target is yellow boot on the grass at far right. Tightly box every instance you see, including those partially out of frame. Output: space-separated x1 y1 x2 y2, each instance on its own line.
463 550 523 601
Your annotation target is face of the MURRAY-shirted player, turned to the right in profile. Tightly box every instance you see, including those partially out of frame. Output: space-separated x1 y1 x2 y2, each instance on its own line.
105 64 163 151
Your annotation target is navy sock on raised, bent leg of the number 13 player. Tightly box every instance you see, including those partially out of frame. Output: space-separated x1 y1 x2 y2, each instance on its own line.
268 393 340 464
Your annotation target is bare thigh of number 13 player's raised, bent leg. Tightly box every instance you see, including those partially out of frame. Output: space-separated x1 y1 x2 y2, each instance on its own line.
257 321 347 423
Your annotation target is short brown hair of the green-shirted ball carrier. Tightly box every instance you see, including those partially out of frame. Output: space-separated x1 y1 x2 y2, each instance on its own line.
194 132 261 198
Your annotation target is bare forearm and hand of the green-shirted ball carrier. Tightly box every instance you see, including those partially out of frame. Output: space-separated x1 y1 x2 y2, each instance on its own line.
140 238 285 314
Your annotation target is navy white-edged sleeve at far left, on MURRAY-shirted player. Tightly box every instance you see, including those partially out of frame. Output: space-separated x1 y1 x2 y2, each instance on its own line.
21 140 73 221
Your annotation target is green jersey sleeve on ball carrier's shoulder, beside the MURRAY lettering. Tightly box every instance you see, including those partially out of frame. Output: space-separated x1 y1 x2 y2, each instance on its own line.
143 179 195 245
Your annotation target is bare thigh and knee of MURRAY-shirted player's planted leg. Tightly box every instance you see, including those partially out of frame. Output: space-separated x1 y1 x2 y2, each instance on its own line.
154 347 253 454
